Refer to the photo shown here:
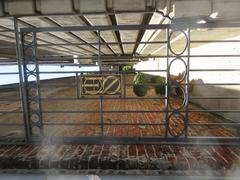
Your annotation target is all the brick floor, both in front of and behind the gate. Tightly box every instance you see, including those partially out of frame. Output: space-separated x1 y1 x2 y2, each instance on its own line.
0 78 240 173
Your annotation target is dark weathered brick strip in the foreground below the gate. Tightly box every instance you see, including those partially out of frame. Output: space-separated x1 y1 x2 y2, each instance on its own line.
0 145 240 171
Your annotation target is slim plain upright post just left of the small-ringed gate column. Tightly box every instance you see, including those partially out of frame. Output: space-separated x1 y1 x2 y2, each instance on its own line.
13 17 30 143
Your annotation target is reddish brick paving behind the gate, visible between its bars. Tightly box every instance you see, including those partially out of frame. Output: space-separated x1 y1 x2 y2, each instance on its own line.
0 88 239 137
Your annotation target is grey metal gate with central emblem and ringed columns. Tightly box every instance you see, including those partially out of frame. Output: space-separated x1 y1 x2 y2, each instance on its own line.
10 25 239 143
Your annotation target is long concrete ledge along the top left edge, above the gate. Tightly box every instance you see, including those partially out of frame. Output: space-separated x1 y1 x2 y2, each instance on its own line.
0 0 166 16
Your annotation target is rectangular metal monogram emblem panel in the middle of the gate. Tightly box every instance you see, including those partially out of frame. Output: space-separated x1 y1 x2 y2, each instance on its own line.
81 75 121 95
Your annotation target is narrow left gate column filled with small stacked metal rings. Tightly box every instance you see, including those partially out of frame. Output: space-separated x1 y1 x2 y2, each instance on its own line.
21 32 43 141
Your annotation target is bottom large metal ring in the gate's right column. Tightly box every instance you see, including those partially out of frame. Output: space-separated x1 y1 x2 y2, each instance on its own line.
167 112 186 138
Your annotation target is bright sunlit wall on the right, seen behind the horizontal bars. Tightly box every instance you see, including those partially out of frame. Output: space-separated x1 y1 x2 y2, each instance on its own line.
136 37 240 122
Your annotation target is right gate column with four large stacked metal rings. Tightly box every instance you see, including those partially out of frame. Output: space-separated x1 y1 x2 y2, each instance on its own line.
165 29 190 139
